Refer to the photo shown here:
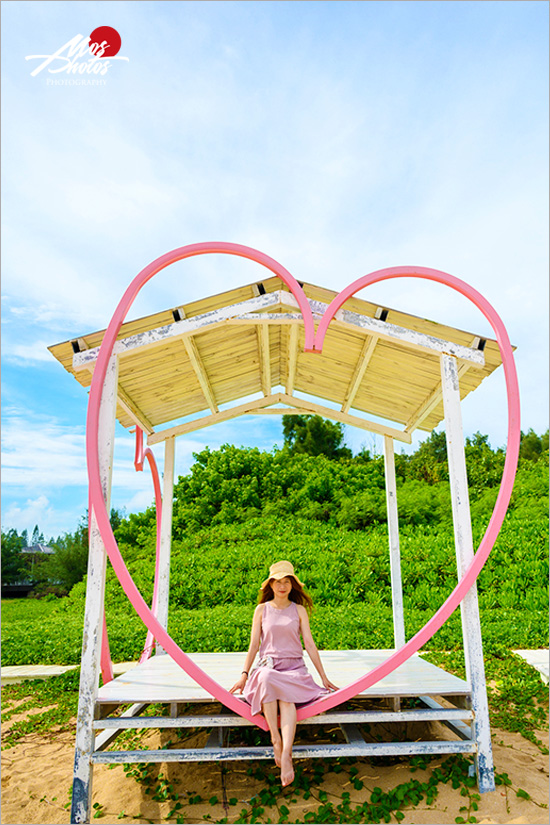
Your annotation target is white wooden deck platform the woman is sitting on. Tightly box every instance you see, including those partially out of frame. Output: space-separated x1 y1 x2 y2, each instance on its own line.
91 650 477 763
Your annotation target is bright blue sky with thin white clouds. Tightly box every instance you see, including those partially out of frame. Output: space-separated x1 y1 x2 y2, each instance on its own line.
2 0 548 538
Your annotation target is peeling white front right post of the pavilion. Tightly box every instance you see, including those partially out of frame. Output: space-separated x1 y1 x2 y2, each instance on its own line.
441 354 495 793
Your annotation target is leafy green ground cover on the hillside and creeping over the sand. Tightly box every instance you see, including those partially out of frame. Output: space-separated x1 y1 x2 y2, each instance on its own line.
2 434 548 823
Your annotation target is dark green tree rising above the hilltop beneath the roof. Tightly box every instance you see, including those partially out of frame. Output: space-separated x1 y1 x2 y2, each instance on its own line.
283 415 352 458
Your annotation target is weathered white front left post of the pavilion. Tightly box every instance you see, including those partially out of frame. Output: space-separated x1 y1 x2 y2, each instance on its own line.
71 356 118 823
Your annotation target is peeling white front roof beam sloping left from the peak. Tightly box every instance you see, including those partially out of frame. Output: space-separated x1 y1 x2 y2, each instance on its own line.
73 292 280 371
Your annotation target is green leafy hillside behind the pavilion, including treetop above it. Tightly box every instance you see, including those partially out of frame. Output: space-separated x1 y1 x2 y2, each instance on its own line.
3 417 548 664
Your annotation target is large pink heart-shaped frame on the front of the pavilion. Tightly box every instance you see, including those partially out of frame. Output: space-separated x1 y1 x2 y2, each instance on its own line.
86 243 520 730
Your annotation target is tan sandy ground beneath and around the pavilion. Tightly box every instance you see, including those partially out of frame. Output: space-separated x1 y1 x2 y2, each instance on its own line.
1 708 549 825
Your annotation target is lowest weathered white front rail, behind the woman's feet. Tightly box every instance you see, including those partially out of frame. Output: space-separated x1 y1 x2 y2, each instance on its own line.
92 741 476 764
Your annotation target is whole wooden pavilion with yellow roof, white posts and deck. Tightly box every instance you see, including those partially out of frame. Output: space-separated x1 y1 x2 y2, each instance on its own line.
50 268 501 822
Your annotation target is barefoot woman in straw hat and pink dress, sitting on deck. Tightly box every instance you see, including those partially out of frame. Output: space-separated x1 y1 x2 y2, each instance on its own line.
230 561 338 787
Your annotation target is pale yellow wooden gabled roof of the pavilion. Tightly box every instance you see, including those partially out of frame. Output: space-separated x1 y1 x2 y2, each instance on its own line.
49 277 501 443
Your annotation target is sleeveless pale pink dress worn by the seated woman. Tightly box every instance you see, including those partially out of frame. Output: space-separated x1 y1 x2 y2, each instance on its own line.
242 601 330 714
